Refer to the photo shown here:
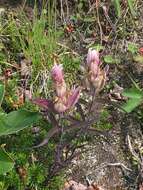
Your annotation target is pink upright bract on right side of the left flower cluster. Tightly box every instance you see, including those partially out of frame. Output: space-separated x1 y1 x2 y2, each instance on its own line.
67 87 81 109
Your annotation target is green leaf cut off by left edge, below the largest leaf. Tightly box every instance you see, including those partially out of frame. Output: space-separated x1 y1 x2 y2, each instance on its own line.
0 147 14 174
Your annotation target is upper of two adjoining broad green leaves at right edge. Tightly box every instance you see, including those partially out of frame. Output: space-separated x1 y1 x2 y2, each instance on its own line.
122 88 143 99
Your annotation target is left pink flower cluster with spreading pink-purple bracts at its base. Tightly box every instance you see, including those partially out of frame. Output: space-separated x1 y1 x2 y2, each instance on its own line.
33 64 81 113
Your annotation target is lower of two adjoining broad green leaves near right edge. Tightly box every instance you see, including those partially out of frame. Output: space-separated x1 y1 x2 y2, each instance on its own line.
122 98 141 113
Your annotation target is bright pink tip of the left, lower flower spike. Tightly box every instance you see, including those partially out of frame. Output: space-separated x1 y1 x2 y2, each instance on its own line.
51 64 64 83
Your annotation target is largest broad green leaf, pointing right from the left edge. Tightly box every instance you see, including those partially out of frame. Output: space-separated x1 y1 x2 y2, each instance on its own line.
0 110 40 136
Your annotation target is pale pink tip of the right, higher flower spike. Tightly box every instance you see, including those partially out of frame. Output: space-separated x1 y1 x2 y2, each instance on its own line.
87 48 100 67
